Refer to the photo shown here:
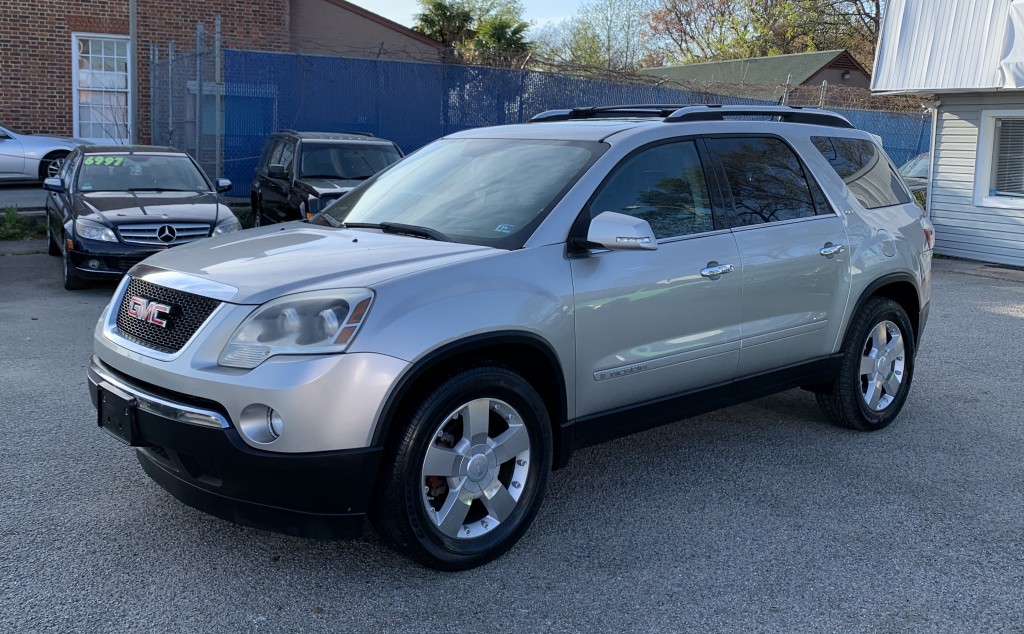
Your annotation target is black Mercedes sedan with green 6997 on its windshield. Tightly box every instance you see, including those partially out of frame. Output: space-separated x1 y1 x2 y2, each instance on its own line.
43 145 242 290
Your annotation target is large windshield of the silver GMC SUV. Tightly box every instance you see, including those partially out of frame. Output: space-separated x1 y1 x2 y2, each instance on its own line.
325 138 606 249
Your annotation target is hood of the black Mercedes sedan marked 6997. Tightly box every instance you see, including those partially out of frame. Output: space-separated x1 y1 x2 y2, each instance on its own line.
72 192 227 226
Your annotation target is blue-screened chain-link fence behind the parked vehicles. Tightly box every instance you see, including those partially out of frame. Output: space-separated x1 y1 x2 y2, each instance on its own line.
151 31 929 198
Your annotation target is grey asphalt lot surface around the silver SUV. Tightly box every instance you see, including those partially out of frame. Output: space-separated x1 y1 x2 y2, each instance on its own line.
0 248 1024 633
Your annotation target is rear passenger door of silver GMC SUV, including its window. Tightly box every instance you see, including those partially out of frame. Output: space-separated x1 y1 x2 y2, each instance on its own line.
707 135 850 377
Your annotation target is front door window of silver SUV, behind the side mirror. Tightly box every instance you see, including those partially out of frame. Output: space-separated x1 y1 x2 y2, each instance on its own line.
590 141 715 239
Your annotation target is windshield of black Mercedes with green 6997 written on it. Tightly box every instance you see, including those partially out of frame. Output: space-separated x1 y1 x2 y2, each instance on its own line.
78 154 210 192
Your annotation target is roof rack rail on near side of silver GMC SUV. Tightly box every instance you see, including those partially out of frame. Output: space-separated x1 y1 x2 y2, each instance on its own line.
529 103 854 128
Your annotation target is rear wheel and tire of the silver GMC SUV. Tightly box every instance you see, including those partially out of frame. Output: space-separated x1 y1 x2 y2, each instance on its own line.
816 297 916 431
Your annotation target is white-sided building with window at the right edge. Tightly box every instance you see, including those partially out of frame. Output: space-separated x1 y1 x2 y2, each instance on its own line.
871 0 1024 266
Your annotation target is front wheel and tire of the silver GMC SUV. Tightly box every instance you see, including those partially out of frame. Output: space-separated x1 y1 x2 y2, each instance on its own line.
373 367 552 570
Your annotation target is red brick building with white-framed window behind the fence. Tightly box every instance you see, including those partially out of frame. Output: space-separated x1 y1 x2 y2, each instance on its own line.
0 0 440 142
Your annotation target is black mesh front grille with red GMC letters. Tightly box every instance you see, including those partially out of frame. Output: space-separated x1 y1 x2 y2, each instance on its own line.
118 278 220 353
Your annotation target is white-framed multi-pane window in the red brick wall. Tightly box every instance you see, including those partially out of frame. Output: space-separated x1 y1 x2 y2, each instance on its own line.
72 34 131 143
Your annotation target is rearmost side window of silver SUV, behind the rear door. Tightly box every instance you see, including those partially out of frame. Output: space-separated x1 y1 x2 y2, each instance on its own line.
811 136 910 209
